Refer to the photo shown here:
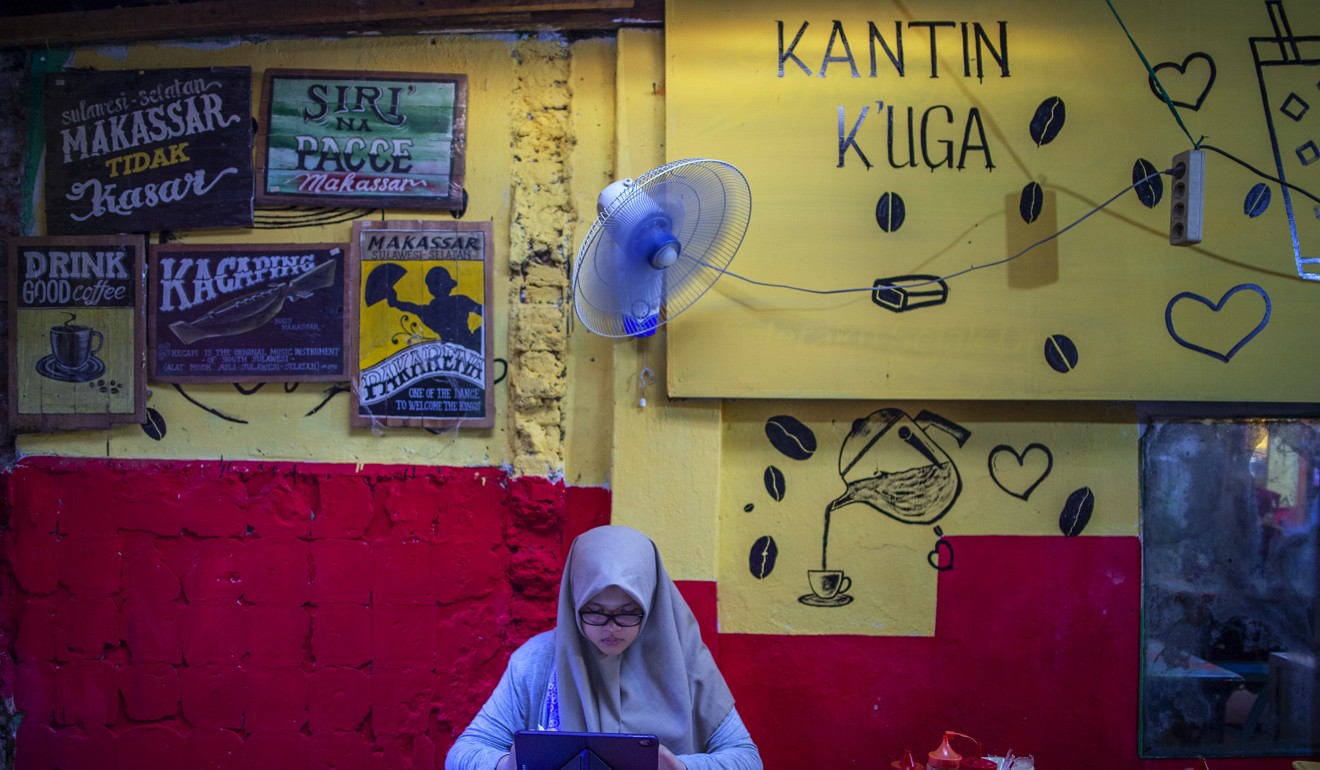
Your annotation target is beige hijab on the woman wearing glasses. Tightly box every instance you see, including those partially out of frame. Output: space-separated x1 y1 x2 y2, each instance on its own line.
554 526 734 754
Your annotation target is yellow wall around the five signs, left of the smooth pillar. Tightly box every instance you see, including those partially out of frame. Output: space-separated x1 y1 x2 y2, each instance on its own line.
18 34 615 485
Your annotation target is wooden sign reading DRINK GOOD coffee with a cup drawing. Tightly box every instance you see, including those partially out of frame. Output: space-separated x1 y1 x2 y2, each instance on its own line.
9 235 147 431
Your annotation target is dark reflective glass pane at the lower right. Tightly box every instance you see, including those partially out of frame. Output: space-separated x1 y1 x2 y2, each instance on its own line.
1140 419 1320 757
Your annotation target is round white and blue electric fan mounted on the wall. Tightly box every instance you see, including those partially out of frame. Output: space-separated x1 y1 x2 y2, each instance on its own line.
573 158 751 337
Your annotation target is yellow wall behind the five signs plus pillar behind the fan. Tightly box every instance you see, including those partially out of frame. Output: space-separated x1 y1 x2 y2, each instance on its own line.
10 30 719 580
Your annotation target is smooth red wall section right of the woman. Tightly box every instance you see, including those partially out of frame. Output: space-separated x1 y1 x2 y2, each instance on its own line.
719 536 1309 770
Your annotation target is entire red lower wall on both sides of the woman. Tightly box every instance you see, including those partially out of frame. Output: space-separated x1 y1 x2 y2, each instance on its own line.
0 458 1290 770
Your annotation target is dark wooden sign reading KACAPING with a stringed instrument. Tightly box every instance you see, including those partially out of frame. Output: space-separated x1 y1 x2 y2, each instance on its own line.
149 243 348 382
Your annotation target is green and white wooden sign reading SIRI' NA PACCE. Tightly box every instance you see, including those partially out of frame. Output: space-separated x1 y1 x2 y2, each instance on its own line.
257 70 467 209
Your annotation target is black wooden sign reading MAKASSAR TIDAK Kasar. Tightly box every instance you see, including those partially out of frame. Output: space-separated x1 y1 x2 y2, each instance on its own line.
46 67 252 235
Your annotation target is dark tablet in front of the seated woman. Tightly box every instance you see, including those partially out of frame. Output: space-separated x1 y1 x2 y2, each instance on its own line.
513 730 660 770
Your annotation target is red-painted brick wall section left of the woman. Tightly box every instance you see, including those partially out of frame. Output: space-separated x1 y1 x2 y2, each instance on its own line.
0 458 609 770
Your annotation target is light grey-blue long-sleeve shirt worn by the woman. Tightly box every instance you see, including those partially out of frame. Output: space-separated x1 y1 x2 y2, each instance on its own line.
445 631 762 770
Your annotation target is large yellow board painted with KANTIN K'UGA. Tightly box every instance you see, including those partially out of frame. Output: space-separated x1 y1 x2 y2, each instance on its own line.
667 0 1320 402
